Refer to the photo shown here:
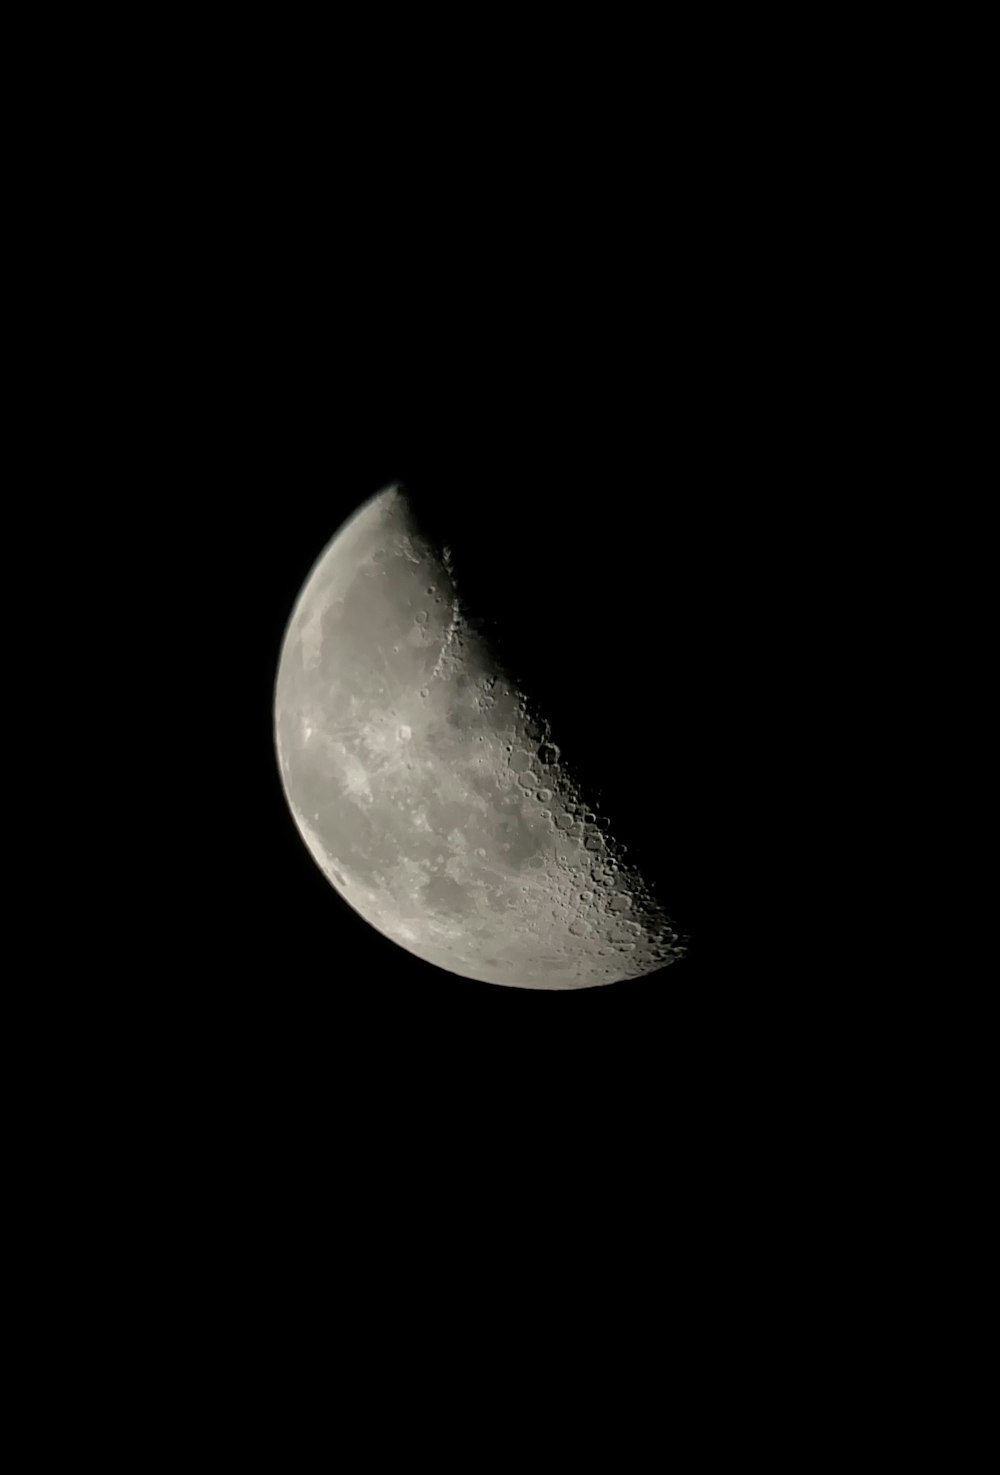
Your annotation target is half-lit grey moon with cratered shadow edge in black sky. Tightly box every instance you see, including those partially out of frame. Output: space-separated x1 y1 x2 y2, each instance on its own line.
274 485 686 990
